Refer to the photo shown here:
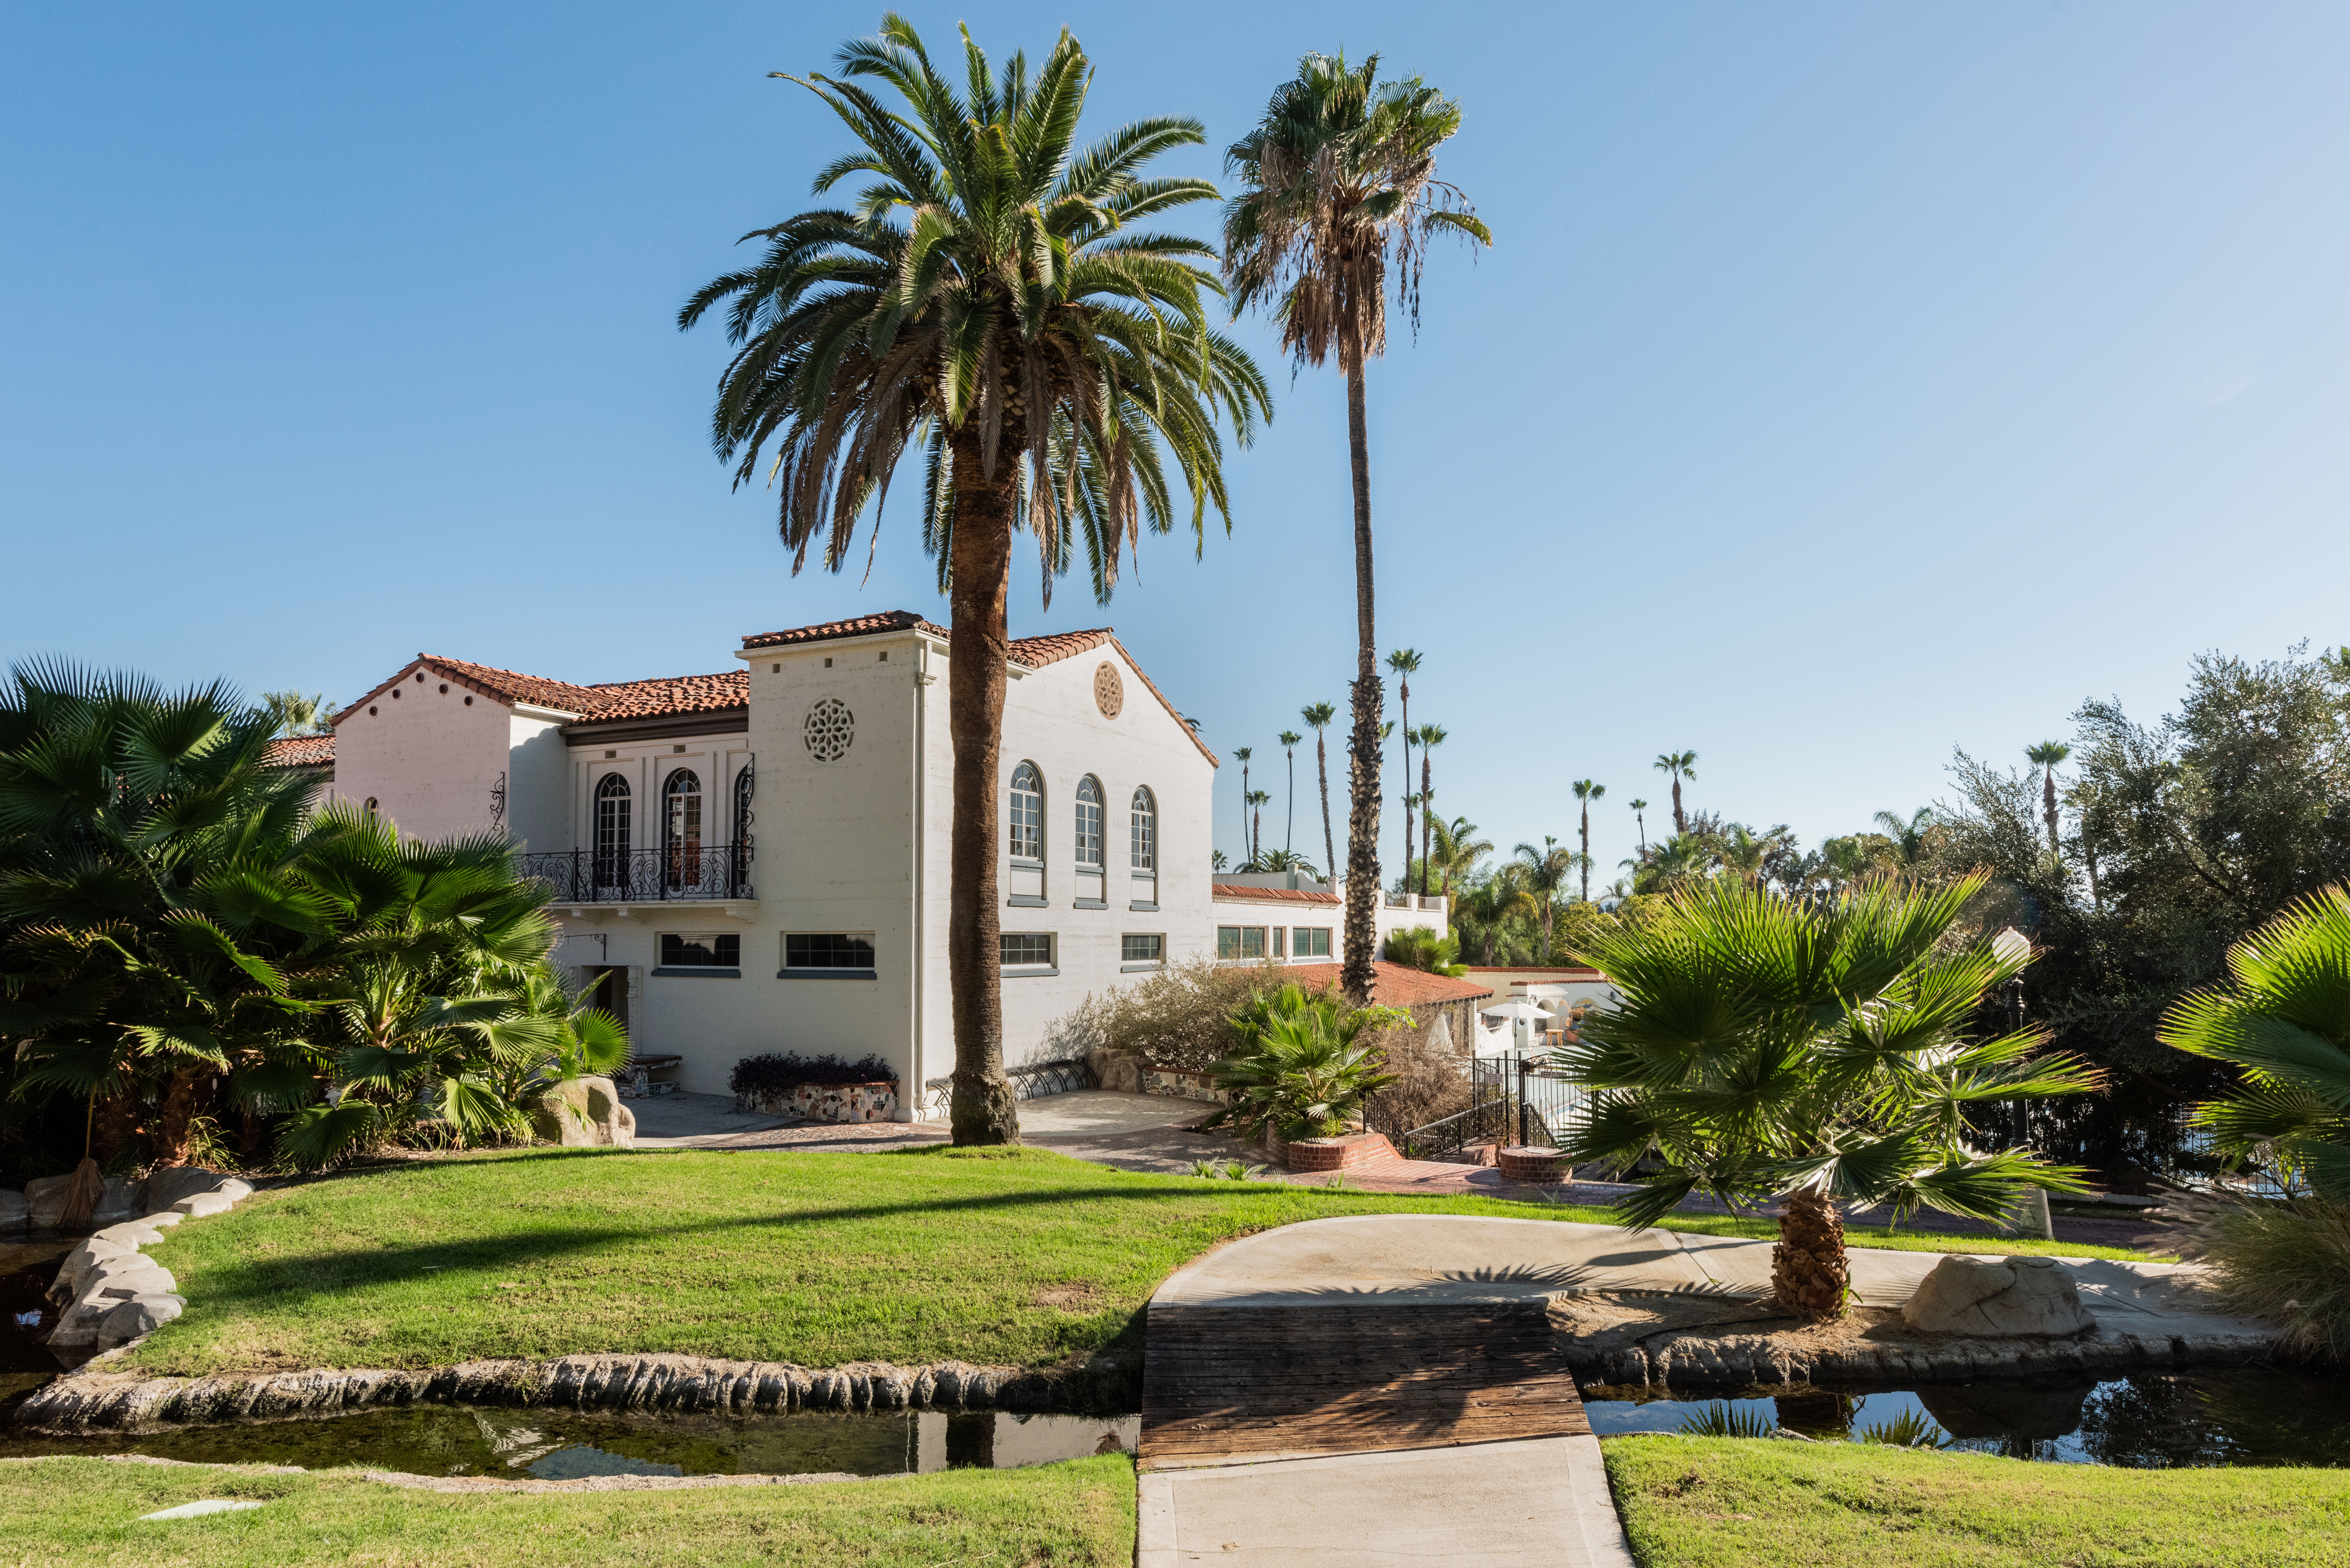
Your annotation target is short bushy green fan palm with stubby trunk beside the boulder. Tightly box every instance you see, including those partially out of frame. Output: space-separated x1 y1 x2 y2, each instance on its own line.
1553 877 2098 1319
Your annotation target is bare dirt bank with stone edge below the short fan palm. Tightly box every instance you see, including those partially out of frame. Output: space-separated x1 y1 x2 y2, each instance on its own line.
1551 1293 2277 1387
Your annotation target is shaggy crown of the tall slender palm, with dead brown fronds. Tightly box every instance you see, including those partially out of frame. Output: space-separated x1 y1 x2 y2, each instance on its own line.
1224 54 1492 364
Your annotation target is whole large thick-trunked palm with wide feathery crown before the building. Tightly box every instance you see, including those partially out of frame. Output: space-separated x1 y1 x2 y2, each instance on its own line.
677 16 1271 1143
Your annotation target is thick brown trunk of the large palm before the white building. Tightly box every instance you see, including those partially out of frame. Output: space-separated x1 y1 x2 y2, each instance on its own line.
945 446 1020 1145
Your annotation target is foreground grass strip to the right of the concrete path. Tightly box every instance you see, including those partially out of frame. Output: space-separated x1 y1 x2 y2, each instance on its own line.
1600 1436 2350 1568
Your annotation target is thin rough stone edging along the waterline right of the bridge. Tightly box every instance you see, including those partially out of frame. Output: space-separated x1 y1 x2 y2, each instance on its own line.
1560 1330 2277 1387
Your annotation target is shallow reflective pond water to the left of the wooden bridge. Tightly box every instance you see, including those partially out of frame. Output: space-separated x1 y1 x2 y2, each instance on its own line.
0 1406 1142 1481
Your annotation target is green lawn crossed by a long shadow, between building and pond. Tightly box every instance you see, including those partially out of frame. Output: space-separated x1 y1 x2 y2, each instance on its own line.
132 1147 2162 1373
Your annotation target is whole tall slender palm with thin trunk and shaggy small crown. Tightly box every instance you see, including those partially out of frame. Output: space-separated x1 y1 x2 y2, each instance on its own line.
1224 54 1492 1006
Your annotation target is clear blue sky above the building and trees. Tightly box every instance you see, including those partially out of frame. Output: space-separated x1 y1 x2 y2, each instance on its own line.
0 0 2350 879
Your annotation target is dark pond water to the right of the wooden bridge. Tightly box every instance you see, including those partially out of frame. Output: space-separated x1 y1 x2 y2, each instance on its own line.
1584 1368 2350 1469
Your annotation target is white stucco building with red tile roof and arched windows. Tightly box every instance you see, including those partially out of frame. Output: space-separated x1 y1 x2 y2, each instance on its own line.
280 611 1445 1112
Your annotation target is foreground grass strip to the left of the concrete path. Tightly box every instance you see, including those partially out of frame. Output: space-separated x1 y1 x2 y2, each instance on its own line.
0 1455 1135 1568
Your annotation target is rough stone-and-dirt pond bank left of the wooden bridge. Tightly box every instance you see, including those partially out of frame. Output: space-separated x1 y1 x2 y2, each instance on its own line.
14 1354 1140 1436
